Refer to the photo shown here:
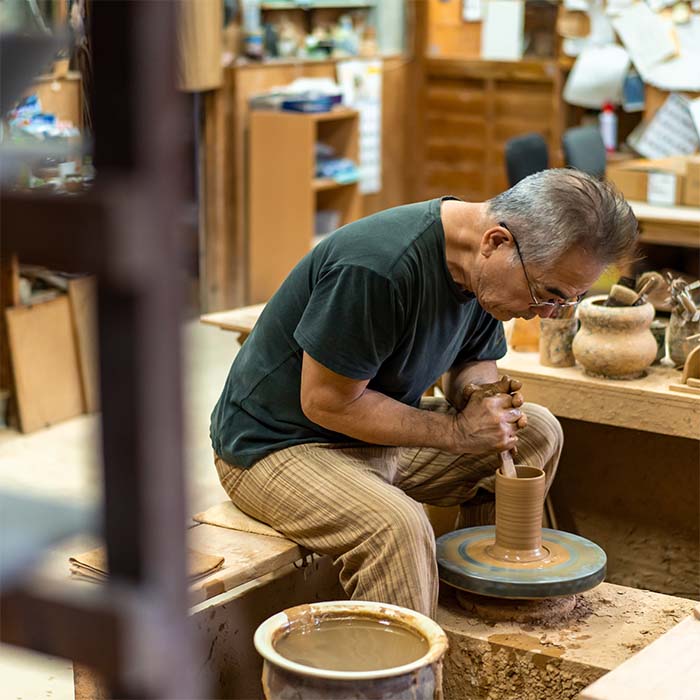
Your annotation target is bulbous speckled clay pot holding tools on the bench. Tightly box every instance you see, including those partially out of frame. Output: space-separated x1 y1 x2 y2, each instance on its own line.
572 295 657 379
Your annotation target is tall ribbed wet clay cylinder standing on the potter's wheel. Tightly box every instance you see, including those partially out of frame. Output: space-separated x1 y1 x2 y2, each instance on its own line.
486 466 549 563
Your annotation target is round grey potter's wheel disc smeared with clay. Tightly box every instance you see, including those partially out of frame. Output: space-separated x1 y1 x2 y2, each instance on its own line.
437 525 606 598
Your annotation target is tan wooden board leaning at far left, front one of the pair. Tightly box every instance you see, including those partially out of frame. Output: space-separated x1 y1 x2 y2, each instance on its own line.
5 295 83 433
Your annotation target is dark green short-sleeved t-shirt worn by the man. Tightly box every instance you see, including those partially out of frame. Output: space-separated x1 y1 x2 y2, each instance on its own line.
211 199 506 467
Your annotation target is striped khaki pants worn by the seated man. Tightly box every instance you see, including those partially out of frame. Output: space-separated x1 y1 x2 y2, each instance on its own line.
215 398 563 618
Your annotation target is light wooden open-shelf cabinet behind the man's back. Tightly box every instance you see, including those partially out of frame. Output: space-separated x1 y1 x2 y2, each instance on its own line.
247 109 362 303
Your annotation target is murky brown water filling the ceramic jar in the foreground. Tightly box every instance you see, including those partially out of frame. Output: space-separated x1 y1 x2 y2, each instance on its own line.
274 616 430 671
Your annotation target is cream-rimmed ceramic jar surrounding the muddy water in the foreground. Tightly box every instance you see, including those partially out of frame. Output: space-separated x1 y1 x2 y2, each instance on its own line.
254 600 447 700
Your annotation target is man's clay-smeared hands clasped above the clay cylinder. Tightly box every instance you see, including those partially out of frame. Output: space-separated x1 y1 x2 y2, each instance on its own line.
453 387 524 455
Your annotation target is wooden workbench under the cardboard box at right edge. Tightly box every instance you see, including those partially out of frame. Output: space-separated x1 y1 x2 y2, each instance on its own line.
629 201 700 248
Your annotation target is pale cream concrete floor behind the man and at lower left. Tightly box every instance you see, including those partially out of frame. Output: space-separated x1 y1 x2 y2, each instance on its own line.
0 320 238 700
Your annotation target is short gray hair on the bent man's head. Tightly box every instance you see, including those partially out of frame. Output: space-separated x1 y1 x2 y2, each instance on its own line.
488 168 638 269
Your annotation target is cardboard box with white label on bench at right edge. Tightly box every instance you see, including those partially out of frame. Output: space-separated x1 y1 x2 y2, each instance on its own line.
606 156 700 206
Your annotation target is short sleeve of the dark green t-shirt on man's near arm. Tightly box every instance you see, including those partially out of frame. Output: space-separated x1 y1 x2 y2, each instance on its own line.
294 265 402 379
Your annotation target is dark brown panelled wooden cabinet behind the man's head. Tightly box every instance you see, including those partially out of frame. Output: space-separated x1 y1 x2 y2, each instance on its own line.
419 59 562 201
